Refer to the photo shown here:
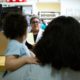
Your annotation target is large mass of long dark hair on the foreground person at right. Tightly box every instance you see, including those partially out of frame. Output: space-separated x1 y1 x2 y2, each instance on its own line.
33 16 80 70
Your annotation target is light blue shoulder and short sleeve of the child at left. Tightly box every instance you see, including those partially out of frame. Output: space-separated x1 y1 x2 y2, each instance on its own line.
5 40 22 56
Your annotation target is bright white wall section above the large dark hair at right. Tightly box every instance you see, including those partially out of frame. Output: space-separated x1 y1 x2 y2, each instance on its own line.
60 0 80 19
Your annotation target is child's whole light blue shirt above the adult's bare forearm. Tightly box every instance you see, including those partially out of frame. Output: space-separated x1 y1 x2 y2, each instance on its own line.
5 40 30 56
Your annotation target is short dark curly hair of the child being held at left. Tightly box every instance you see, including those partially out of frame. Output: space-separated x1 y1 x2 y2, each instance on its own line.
3 13 28 39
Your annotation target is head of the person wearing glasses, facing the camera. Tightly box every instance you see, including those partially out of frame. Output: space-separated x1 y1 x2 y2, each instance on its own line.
30 16 40 32
